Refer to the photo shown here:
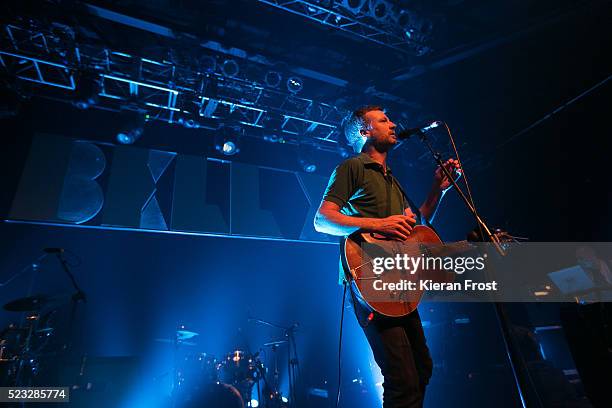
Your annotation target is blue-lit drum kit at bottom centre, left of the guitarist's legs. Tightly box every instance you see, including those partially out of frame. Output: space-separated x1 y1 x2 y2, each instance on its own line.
166 325 289 408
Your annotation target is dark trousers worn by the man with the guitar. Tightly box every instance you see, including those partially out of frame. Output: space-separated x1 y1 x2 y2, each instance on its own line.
353 298 433 408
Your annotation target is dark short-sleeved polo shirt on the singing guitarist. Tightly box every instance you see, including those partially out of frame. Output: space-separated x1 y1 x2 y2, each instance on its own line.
323 153 409 218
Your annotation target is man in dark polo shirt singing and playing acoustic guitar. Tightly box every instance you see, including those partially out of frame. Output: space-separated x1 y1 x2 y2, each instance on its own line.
314 106 459 408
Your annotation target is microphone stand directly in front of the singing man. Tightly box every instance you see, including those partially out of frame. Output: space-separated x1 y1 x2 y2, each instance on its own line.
417 130 543 408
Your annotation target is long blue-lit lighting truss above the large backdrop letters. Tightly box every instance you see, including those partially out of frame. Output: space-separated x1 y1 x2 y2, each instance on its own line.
0 20 348 151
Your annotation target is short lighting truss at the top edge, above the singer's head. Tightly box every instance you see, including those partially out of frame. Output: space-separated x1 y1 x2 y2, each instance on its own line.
257 0 423 55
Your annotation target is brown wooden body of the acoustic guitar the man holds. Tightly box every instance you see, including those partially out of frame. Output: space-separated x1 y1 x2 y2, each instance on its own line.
340 225 452 317
